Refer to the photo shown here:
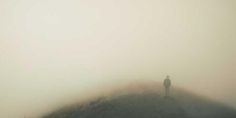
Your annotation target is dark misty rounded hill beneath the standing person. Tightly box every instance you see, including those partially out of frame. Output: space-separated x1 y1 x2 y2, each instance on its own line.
43 84 236 118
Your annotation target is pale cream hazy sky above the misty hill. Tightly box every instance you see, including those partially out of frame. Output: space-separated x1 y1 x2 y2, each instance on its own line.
0 0 236 118
